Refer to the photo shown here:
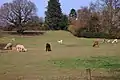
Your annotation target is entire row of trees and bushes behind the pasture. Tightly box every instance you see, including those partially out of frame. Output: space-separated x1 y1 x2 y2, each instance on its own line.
0 0 120 38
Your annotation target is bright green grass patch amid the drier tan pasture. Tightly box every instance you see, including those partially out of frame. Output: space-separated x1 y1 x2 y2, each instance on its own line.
48 56 120 69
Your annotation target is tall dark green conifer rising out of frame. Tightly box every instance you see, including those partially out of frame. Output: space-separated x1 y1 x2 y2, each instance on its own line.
45 0 63 30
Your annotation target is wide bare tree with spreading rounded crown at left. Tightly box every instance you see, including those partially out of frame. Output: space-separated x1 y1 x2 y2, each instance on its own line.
0 0 36 33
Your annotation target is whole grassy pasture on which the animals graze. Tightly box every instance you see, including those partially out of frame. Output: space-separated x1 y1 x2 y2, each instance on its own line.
0 31 120 80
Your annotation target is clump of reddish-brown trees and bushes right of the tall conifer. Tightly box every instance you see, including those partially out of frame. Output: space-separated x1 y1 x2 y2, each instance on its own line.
68 0 120 38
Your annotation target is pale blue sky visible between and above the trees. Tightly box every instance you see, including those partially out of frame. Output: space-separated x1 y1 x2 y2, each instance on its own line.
0 0 95 17
